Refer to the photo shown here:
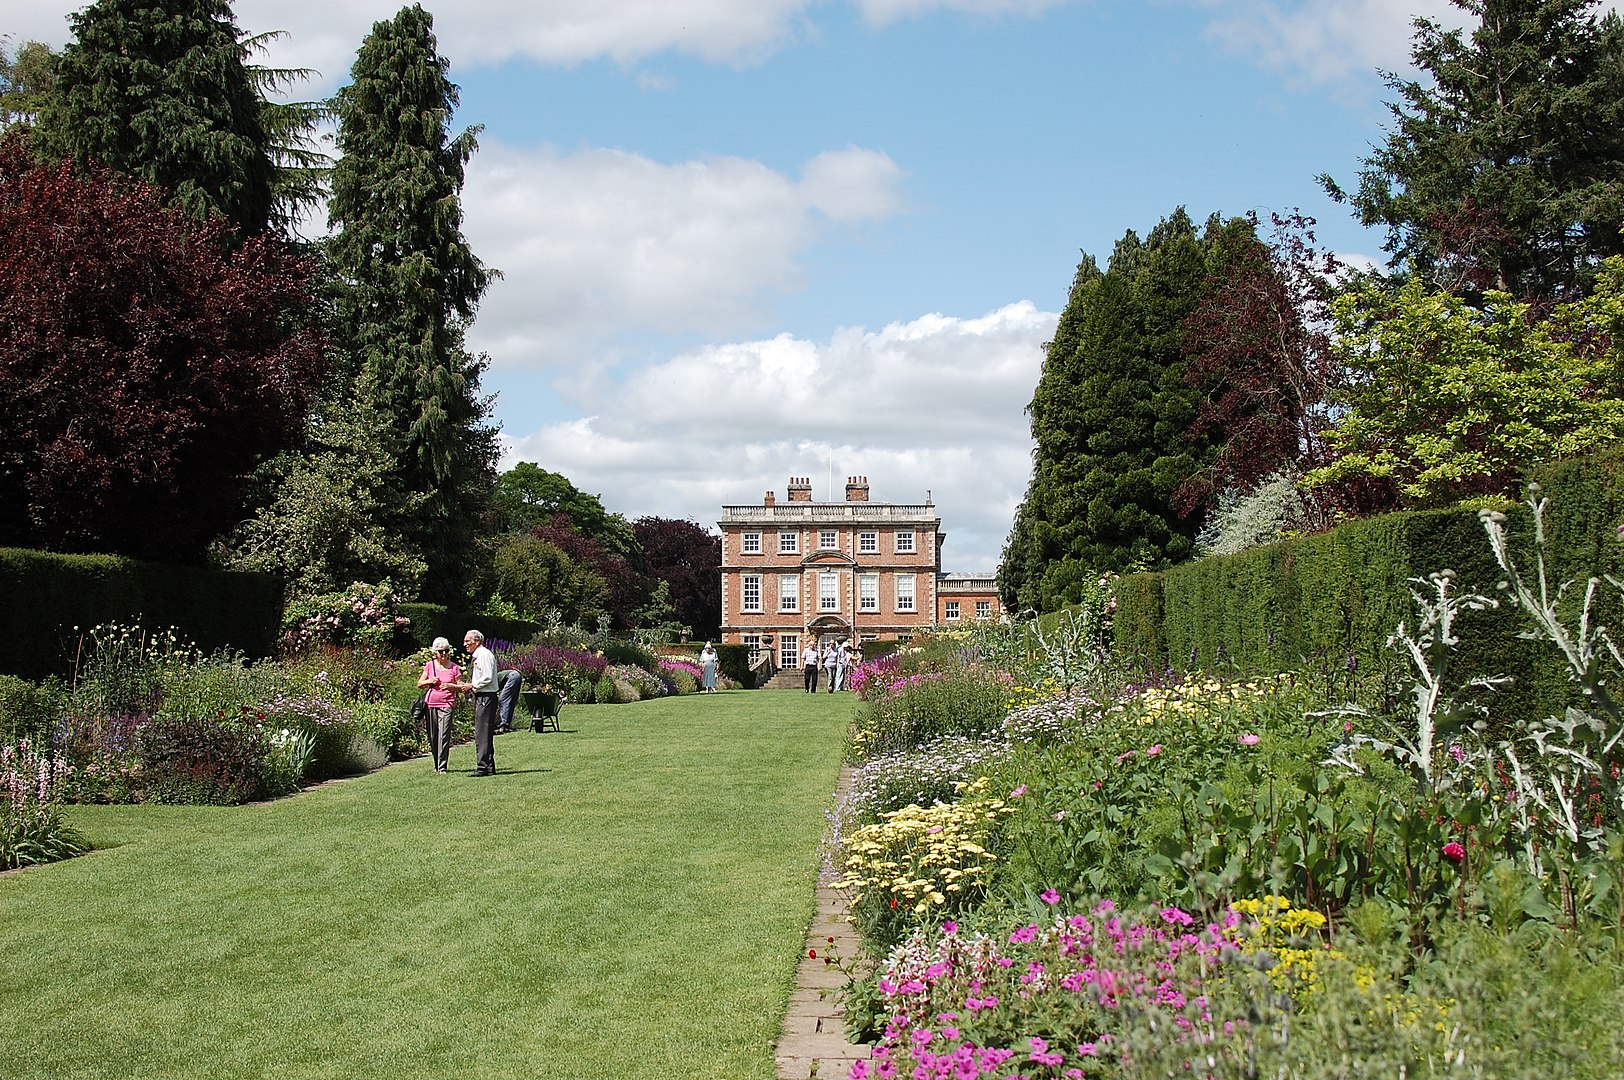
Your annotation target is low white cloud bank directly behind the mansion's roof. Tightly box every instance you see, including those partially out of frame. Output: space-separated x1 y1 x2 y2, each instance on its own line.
503 300 1057 570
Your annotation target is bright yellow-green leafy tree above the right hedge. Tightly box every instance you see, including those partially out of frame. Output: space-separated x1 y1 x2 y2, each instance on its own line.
1307 258 1624 507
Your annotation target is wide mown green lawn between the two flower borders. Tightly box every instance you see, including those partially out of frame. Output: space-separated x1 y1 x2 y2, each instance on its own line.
0 692 854 1080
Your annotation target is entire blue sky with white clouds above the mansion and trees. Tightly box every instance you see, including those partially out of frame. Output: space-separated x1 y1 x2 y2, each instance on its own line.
19 0 1565 572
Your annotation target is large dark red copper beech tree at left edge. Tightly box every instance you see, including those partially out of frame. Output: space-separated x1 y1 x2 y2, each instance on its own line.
0 133 325 560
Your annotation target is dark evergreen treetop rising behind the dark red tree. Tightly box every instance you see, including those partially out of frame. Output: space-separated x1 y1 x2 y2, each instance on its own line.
37 0 274 235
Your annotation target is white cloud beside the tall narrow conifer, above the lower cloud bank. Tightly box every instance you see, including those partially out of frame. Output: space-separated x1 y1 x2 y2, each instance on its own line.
464 141 903 365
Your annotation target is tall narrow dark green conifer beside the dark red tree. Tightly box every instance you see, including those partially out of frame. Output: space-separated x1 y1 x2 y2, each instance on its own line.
328 5 497 599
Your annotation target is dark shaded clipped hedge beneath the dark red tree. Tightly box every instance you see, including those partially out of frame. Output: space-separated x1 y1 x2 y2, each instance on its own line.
0 547 283 679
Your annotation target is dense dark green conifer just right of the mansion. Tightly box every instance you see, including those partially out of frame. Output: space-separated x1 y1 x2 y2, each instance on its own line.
999 210 1220 611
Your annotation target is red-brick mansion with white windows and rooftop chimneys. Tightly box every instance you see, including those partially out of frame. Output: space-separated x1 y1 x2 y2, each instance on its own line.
718 476 1002 667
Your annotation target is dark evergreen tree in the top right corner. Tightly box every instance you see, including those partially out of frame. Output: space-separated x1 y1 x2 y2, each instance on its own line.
1320 0 1624 300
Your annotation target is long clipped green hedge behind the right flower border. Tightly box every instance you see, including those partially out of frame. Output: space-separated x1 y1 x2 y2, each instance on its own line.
1114 451 1624 715
